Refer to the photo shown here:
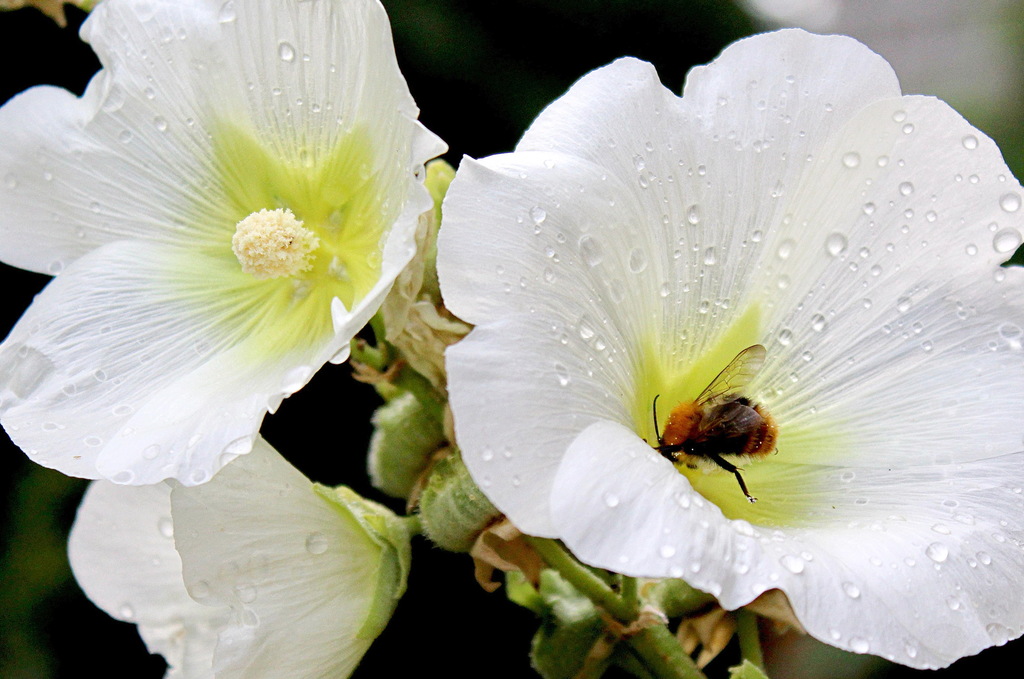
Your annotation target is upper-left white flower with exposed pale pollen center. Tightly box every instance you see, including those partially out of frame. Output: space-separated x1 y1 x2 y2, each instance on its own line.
0 0 443 484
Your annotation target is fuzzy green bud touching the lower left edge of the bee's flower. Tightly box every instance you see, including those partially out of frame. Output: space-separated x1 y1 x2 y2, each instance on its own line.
420 453 501 552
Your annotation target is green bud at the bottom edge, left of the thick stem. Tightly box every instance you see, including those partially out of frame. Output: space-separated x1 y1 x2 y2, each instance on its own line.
529 569 604 679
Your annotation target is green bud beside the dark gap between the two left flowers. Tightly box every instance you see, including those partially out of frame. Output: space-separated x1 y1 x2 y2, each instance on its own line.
368 392 444 498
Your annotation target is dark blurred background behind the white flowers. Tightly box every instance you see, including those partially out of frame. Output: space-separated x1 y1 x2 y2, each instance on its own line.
0 0 1024 679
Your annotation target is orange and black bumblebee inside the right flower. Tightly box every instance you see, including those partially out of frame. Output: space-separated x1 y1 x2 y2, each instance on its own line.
652 344 778 502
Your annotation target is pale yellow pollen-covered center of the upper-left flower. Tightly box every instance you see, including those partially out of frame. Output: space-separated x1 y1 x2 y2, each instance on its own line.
231 209 319 280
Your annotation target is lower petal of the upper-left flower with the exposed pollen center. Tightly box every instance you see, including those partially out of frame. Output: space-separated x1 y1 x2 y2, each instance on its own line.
0 242 337 484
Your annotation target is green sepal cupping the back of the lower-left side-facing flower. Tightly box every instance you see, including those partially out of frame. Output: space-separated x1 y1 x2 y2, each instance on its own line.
313 483 415 639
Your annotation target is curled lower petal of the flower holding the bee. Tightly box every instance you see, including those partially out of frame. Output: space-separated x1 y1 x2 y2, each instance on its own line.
552 422 1024 668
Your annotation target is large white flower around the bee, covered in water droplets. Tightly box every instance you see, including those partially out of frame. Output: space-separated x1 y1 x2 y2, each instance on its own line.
438 31 1024 668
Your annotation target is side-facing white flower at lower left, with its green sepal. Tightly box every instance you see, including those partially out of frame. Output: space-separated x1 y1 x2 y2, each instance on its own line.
69 438 409 679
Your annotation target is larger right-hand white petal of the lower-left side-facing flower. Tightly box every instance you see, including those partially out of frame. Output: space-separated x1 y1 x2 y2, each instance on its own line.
172 439 397 679
